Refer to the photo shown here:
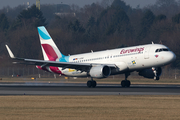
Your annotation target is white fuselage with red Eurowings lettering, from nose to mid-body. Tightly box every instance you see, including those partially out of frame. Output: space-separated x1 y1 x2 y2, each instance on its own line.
59 44 176 77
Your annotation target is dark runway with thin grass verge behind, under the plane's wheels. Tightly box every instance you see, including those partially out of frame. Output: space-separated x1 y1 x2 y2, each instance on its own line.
0 78 180 95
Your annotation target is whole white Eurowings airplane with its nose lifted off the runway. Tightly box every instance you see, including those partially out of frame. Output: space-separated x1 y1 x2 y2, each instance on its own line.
5 26 176 87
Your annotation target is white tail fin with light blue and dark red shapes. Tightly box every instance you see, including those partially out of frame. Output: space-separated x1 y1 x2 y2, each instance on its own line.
38 26 63 61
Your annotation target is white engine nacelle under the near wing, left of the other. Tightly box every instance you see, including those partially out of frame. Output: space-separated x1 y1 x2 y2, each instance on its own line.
89 65 111 79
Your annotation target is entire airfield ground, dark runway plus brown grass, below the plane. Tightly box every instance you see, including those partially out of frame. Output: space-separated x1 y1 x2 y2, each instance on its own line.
0 78 180 120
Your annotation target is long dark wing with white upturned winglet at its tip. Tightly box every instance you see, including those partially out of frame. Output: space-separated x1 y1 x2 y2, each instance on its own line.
6 45 117 71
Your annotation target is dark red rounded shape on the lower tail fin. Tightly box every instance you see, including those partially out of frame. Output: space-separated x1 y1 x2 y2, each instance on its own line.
41 44 58 61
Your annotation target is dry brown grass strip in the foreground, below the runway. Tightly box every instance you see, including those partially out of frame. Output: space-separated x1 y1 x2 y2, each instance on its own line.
0 96 180 120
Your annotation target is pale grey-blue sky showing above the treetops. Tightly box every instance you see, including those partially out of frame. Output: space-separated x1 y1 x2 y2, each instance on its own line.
0 0 156 9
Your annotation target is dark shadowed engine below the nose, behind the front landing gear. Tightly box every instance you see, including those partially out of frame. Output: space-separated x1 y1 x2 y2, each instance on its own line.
139 67 162 80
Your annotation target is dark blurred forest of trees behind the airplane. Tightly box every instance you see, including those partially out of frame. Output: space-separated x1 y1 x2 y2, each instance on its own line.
0 0 180 68
